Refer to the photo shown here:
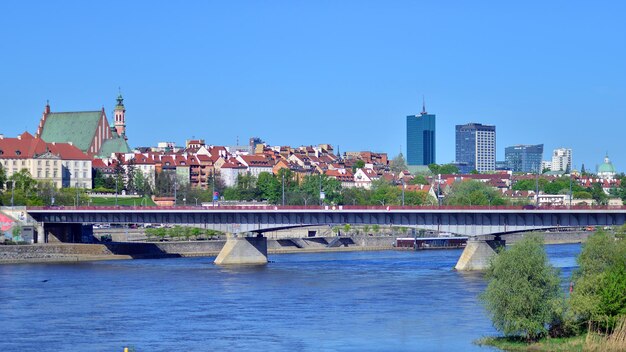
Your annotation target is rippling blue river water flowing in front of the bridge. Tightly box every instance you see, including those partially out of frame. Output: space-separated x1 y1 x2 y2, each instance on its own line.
0 245 580 352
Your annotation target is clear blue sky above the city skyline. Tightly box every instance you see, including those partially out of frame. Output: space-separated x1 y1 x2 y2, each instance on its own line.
0 1 626 170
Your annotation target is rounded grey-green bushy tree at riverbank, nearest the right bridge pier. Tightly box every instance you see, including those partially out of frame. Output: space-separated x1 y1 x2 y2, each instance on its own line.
480 236 563 341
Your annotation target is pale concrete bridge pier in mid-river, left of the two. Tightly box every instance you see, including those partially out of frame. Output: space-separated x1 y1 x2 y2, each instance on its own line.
214 235 267 265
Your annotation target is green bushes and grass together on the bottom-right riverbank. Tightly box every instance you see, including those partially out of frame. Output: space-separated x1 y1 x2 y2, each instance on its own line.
477 231 626 351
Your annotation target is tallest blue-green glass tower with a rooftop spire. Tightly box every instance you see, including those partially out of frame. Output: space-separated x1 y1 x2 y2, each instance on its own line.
406 99 436 165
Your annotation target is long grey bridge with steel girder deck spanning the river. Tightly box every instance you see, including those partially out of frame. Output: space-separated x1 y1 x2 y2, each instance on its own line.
27 206 626 269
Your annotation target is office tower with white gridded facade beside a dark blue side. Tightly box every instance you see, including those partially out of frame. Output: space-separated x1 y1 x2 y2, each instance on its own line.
456 123 496 173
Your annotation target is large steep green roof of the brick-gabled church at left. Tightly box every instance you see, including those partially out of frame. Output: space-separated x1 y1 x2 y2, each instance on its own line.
41 111 102 152
